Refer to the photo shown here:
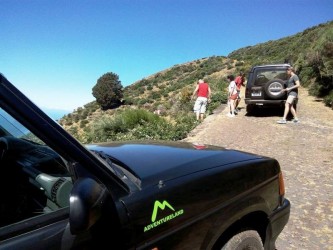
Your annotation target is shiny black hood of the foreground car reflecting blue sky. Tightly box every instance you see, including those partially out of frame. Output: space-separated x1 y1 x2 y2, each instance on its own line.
87 141 260 186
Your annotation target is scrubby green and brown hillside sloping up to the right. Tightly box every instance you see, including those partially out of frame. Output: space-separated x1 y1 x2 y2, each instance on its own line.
59 21 333 143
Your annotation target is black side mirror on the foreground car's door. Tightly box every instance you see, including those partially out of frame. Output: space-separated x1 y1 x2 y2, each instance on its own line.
69 178 108 234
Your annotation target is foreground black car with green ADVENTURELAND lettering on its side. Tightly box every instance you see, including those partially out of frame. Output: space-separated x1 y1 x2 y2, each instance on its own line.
0 74 290 250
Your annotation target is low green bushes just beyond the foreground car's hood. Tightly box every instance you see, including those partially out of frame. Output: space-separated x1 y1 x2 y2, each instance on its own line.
74 108 195 143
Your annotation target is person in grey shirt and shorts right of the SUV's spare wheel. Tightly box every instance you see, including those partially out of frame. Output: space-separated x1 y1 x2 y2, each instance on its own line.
277 67 301 124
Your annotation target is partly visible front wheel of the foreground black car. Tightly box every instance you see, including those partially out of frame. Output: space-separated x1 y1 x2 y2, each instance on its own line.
222 230 264 250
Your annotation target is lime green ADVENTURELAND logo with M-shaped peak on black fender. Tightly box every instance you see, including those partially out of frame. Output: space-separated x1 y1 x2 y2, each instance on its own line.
143 200 184 232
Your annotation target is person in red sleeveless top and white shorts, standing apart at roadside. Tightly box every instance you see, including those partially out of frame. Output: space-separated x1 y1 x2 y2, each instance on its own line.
191 79 211 121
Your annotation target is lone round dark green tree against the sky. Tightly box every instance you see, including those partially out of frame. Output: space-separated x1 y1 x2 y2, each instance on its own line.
92 72 123 110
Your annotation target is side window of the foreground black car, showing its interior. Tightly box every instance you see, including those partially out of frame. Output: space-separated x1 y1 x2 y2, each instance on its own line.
0 105 73 228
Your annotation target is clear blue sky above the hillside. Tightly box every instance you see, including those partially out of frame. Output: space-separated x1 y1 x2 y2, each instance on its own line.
0 0 333 112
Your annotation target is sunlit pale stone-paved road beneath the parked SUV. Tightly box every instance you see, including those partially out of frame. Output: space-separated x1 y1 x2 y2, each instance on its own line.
184 88 333 250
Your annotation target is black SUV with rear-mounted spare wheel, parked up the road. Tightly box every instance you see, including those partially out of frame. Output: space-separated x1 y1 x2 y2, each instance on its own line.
244 64 297 113
